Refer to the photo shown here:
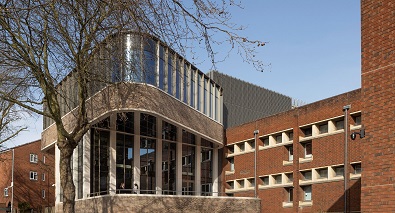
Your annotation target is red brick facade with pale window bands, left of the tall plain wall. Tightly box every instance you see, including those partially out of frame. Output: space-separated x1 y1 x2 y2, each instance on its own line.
224 90 362 212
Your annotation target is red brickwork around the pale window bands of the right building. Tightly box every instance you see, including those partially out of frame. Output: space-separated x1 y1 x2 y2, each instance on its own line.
223 89 362 212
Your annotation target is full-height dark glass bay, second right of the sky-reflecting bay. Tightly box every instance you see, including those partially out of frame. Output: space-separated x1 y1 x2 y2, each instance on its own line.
182 130 196 195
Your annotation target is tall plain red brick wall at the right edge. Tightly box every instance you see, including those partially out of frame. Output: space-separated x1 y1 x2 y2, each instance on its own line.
361 0 395 212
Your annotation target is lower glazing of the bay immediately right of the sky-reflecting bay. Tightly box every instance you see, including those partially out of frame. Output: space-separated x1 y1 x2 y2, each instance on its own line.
162 142 177 194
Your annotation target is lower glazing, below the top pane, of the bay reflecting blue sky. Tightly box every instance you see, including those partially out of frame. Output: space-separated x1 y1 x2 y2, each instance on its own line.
139 137 156 194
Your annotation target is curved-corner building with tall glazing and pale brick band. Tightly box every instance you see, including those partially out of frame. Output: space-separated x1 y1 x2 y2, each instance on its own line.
42 32 266 212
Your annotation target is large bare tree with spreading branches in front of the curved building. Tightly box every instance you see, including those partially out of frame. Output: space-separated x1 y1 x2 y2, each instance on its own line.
0 0 265 212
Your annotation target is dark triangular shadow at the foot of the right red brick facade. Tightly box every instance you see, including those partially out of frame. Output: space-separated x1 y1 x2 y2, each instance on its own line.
328 179 361 212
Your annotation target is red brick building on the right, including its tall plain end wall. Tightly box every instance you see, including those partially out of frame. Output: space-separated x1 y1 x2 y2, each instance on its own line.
224 0 395 212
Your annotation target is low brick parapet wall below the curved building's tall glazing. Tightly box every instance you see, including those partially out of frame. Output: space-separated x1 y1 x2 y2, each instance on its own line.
56 195 260 213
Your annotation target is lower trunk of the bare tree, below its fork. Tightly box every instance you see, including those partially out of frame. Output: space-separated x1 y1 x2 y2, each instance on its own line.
59 145 75 213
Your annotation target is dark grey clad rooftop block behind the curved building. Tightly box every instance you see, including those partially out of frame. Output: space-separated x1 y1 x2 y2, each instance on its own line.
207 71 292 128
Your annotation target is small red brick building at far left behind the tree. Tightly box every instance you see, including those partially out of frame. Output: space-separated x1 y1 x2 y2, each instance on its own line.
0 140 55 212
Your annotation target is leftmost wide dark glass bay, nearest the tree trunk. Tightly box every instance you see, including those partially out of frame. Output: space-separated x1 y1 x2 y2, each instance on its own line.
91 118 110 195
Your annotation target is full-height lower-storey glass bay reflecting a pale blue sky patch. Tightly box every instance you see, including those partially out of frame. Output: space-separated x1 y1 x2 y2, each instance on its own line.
139 113 156 194
